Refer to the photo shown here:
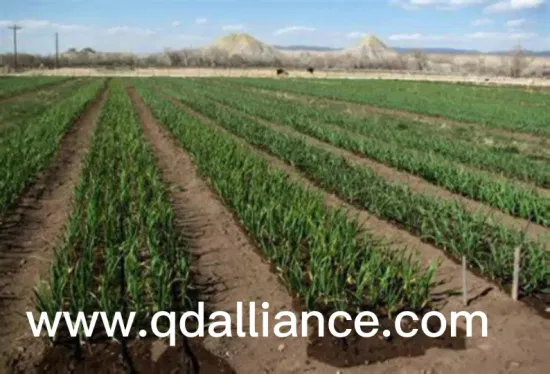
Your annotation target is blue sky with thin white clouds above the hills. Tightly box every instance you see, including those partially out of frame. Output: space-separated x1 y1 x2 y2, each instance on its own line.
0 0 550 54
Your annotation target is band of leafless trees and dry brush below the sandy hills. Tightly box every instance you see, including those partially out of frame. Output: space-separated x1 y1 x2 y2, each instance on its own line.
0 47 550 77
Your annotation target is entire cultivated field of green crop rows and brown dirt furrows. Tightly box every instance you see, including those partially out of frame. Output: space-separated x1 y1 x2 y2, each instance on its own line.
0 77 550 373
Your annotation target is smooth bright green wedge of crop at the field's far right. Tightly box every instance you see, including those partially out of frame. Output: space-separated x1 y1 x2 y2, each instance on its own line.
227 79 550 136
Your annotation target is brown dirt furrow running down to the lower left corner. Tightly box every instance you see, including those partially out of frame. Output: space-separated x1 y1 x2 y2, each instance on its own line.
0 86 107 373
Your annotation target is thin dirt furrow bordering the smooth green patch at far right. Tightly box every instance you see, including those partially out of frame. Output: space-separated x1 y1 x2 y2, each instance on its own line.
252 88 550 147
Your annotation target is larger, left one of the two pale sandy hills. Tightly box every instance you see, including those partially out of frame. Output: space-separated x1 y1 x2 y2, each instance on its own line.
203 34 283 64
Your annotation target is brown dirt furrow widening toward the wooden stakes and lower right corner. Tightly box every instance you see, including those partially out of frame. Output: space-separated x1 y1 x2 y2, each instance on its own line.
160 93 550 374
